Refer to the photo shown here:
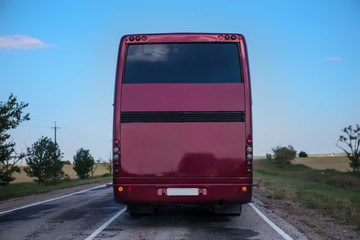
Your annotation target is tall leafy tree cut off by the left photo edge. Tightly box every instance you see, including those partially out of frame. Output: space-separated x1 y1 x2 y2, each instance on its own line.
0 94 30 186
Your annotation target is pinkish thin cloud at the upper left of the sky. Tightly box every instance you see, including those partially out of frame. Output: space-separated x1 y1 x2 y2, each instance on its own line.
0 35 53 49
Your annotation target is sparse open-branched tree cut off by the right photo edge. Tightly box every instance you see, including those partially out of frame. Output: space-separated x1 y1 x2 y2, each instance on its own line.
336 124 360 172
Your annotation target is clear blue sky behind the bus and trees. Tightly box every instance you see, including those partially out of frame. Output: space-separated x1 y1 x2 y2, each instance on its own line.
0 0 360 160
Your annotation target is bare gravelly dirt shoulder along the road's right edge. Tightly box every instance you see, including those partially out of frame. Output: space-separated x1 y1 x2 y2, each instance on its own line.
253 187 360 240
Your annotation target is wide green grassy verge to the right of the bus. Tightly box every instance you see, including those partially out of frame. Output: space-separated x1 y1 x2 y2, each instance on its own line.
254 160 360 230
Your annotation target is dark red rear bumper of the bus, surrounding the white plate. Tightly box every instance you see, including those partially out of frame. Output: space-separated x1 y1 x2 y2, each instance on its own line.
113 183 252 204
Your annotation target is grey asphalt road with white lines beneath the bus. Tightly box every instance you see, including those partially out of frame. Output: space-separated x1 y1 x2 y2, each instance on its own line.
0 187 304 240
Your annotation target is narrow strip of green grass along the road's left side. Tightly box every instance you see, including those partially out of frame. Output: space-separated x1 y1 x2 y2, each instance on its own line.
0 174 112 201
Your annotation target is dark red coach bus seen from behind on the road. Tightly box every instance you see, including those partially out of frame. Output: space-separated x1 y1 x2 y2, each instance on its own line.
113 33 253 215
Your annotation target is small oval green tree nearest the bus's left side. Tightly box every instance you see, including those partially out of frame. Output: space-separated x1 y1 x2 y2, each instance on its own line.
73 148 95 179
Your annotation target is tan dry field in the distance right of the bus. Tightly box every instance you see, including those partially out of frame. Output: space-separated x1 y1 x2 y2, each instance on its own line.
291 156 351 172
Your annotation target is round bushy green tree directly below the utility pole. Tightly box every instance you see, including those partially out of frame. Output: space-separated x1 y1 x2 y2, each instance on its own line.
24 137 64 184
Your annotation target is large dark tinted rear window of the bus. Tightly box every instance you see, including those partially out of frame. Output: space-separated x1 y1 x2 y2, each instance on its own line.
123 43 241 83
